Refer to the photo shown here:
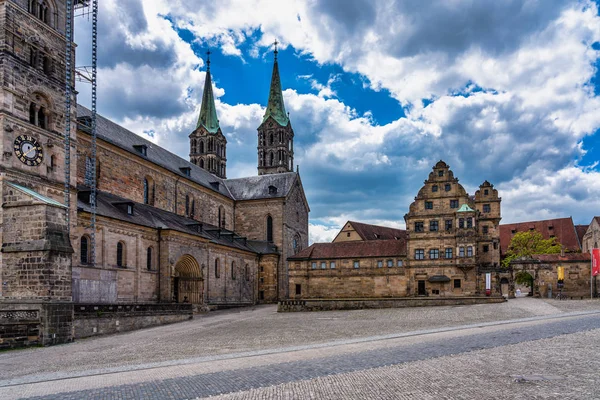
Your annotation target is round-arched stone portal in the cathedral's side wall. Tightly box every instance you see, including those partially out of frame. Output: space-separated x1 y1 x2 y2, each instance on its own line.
172 254 204 304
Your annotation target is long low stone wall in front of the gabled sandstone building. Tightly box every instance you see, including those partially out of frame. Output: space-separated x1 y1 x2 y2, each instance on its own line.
277 297 506 312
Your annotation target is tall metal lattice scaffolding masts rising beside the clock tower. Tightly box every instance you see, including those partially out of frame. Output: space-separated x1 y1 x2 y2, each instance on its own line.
65 0 98 265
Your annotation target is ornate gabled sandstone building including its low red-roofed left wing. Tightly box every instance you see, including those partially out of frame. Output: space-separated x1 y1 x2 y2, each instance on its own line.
288 161 507 298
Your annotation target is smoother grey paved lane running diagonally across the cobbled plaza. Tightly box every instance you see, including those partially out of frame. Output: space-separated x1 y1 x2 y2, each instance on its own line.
21 314 600 399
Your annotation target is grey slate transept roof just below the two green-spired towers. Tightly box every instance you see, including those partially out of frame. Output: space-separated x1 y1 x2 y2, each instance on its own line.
225 172 298 200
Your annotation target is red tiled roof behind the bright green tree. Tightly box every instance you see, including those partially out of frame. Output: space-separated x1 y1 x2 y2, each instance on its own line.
500 217 581 254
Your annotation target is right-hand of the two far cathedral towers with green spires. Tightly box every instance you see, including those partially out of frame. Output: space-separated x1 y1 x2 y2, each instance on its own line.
258 42 294 175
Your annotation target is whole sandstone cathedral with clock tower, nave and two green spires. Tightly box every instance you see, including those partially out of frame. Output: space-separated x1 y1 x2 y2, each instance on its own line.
0 0 310 344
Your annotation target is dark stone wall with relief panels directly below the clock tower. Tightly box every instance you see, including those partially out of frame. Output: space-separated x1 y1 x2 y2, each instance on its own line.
0 300 73 349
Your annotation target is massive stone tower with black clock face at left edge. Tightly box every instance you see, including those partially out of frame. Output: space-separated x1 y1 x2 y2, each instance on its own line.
0 0 76 301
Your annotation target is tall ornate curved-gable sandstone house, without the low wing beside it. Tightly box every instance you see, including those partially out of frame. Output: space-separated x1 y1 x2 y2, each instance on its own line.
404 161 501 295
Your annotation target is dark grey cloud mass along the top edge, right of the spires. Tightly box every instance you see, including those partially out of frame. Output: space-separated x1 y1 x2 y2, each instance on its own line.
311 0 569 58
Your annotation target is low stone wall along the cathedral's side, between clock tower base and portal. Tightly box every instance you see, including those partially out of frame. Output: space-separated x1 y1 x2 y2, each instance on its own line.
74 303 193 339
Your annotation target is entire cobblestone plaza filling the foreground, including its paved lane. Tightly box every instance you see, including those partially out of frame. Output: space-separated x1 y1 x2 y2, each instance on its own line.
0 298 600 399
